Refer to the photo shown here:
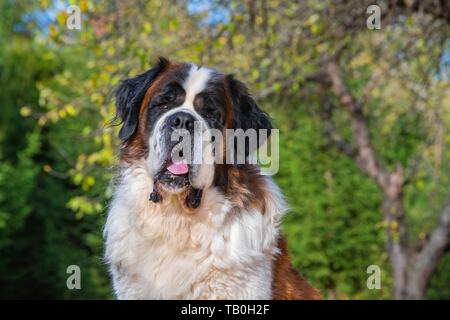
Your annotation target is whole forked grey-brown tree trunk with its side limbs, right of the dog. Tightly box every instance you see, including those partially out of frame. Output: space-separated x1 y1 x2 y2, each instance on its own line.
324 58 450 299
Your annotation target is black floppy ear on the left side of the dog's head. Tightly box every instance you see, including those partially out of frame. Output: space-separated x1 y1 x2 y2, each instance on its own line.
116 57 169 140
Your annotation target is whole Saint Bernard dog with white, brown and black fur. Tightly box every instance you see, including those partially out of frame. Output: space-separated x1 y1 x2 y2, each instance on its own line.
104 58 321 299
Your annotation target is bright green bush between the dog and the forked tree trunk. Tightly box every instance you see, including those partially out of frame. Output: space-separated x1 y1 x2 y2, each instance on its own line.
276 107 391 299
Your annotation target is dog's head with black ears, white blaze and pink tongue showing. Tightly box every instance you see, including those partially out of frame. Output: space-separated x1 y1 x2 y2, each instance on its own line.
116 58 271 193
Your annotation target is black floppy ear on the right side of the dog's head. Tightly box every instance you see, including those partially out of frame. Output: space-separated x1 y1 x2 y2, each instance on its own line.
227 75 272 151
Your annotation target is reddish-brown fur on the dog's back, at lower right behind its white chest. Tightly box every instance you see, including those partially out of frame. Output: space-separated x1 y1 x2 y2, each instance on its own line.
272 236 322 300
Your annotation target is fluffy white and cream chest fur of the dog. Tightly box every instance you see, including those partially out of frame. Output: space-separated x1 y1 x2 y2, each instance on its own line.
105 165 285 299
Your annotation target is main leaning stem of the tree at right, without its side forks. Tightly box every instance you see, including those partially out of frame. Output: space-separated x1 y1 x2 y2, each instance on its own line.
324 58 409 298
